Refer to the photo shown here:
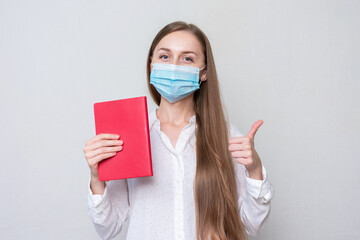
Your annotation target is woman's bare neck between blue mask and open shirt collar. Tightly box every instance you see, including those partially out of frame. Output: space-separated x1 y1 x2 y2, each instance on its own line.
156 94 195 125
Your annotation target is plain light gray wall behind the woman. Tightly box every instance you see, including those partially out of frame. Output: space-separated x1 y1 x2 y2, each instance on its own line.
0 0 360 240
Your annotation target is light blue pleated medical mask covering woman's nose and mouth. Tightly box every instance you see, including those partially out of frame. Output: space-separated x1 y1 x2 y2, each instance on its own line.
150 63 205 103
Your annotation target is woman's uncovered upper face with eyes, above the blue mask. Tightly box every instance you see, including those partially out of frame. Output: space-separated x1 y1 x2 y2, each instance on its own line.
151 31 205 69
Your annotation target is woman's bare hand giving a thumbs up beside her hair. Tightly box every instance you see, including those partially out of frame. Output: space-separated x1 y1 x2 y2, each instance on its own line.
229 120 263 180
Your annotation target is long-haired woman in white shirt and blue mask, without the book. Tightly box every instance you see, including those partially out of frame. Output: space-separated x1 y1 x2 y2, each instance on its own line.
84 22 272 240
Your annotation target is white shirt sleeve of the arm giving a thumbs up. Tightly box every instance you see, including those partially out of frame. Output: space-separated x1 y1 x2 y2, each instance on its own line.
229 124 273 236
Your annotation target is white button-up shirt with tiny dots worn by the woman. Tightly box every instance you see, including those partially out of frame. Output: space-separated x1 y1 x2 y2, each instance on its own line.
88 110 273 240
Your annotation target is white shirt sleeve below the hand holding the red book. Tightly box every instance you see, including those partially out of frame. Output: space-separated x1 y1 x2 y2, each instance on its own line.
87 179 130 239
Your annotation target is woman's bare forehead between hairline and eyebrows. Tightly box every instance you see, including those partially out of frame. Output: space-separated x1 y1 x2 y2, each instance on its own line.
155 31 202 53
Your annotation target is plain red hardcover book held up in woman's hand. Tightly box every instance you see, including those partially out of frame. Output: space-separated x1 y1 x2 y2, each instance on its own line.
94 97 153 181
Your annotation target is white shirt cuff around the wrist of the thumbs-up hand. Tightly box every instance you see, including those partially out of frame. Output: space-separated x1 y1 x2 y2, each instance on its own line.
245 166 273 202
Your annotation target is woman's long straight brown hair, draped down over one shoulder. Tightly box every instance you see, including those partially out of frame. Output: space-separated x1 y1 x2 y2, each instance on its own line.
147 21 246 240
